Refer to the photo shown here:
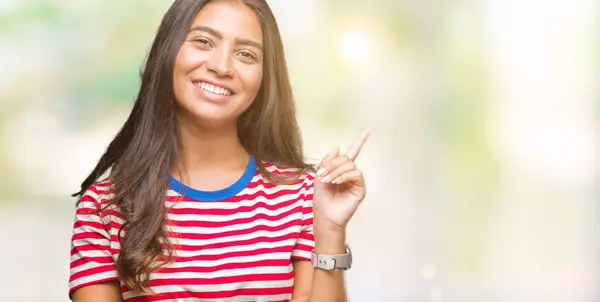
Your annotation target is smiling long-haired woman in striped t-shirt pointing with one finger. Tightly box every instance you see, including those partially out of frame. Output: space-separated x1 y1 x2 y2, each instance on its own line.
69 0 368 302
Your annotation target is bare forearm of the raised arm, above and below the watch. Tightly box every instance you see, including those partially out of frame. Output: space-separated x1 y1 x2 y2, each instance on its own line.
310 231 347 302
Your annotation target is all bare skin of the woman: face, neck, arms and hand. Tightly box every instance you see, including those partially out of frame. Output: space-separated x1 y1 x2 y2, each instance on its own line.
73 1 369 302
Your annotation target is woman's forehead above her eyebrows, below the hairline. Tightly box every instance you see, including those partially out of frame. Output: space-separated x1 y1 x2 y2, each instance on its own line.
192 0 263 42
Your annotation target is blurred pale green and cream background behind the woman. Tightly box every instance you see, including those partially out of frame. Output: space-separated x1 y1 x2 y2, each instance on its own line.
0 0 600 302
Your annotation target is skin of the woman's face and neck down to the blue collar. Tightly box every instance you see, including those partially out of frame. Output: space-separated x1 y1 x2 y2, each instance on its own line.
173 1 263 191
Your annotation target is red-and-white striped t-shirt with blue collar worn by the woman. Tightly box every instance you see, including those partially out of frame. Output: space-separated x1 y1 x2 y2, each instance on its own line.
69 158 314 302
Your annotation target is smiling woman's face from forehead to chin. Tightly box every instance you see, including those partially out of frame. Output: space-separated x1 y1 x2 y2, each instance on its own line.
173 0 263 128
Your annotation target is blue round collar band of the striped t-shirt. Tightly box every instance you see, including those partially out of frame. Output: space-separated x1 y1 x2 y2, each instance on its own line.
169 155 257 201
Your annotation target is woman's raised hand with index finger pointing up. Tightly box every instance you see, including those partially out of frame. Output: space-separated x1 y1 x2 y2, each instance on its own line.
313 129 370 231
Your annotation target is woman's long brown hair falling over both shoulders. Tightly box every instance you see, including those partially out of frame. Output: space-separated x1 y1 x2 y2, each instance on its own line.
73 0 312 291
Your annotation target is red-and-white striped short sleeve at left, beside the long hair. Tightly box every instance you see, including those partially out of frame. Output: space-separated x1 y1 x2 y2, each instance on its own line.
69 186 118 298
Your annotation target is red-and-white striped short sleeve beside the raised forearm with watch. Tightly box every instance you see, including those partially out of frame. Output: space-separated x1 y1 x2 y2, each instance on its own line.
292 173 315 261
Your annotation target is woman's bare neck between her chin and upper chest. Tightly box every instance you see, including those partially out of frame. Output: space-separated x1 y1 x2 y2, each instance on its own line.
178 119 249 172
